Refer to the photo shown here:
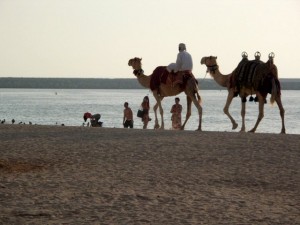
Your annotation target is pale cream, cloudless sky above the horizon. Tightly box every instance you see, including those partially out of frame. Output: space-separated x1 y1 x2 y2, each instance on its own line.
0 0 300 79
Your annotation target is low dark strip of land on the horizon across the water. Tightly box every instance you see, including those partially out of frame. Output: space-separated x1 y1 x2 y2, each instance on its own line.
0 77 300 90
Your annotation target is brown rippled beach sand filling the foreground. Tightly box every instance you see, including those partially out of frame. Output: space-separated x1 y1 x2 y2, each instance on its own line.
0 125 300 225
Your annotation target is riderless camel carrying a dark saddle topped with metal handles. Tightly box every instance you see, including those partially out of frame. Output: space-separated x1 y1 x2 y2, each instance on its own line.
201 52 285 134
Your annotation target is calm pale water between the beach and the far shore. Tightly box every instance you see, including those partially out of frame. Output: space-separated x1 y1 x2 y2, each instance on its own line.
0 89 300 134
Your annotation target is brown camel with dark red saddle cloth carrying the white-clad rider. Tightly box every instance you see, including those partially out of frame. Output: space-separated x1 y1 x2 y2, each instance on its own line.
128 58 202 131
